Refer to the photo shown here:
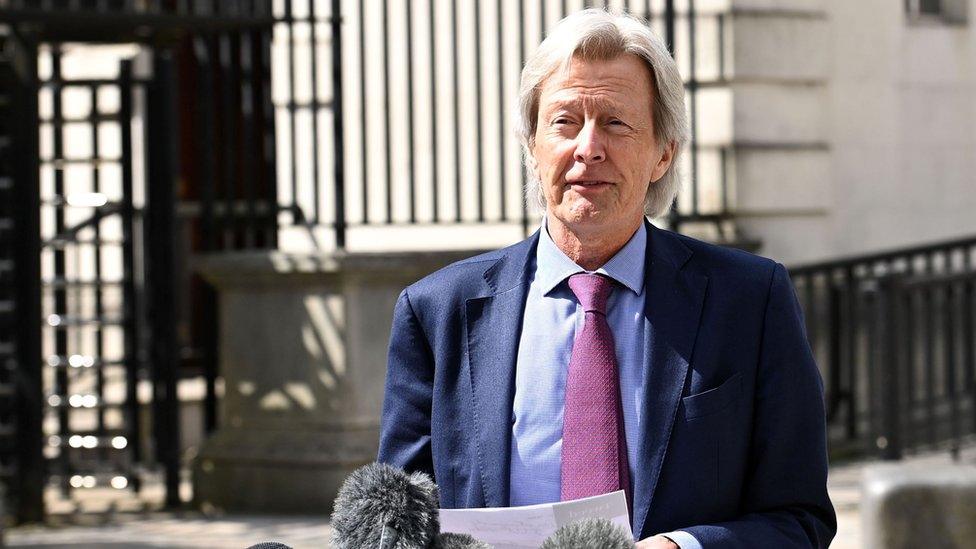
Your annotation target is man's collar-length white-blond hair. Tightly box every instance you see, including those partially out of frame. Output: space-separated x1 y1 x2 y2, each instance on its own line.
515 9 688 217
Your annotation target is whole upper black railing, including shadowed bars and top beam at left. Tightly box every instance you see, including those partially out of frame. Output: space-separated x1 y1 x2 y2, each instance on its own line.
0 0 732 251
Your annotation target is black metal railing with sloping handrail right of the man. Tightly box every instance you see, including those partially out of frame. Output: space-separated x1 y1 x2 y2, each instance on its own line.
790 238 976 456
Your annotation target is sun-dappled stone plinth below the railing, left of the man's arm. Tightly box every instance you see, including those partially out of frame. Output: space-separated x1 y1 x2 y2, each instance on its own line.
193 248 474 515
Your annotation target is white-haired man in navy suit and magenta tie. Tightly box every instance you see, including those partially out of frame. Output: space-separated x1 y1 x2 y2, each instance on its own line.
379 10 836 549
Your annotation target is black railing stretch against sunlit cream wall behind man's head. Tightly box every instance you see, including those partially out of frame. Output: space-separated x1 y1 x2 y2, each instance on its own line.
264 0 732 248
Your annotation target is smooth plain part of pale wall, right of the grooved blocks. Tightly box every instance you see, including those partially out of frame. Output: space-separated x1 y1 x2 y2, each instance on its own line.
830 0 976 253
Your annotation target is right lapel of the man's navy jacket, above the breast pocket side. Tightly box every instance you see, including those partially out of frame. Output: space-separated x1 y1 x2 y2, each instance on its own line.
634 223 708 534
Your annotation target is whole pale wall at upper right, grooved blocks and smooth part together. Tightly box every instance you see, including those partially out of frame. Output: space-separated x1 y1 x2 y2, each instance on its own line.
733 0 976 263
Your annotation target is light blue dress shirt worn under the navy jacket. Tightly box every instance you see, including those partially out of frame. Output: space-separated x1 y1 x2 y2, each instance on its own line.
509 219 701 549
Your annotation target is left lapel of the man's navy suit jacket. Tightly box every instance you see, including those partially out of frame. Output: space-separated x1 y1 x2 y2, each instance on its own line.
464 232 539 507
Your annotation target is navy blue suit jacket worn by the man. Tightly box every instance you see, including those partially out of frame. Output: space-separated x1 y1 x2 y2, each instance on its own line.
379 224 836 548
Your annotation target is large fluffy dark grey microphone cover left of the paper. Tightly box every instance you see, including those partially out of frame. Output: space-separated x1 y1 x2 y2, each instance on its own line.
332 463 440 549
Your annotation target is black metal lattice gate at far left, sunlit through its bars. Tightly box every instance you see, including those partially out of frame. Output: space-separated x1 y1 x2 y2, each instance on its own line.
40 43 155 508
